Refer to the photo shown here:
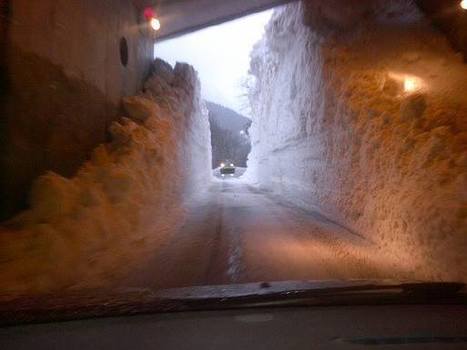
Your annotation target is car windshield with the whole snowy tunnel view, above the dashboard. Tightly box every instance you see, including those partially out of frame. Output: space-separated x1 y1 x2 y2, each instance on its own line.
0 0 467 317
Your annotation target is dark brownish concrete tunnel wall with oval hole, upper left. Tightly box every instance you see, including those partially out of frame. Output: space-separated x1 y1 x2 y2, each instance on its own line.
0 0 152 218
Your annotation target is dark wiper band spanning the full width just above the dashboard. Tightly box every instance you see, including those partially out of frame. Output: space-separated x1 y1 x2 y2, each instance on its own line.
0 280 467 326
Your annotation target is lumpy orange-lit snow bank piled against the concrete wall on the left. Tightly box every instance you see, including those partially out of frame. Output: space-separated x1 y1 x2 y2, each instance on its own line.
0 60 211 293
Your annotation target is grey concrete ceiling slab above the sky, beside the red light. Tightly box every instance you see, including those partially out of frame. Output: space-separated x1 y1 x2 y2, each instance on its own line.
133 0 294 40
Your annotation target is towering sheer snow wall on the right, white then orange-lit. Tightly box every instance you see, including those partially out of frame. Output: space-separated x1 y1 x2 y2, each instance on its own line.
248 0 467 280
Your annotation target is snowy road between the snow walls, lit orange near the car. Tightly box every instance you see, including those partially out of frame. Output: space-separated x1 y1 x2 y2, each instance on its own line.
120 179 410 289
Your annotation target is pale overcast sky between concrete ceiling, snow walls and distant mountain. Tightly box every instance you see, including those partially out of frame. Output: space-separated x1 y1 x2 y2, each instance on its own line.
154 10 272 114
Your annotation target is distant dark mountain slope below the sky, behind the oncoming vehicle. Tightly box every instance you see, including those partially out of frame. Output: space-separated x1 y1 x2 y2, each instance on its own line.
206 101 251 169
